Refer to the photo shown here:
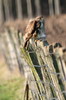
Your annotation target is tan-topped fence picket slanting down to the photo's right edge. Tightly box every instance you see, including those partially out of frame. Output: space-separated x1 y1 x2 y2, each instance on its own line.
54 47 66 89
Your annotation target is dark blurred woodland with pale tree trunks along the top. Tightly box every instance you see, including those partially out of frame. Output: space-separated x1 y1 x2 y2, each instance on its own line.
0 0 66 20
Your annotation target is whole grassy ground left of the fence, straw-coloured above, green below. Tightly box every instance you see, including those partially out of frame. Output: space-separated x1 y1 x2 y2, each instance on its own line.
0 56 25 100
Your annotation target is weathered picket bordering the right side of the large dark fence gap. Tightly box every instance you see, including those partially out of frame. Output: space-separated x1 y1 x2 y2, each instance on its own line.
36 47 53 100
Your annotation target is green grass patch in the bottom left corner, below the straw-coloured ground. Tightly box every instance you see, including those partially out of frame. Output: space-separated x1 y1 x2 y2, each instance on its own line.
0 78 24 100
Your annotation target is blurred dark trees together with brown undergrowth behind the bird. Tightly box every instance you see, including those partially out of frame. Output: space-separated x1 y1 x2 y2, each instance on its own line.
0 0 66 46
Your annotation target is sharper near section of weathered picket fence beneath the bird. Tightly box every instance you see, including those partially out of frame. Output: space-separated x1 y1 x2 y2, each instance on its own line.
21 38 66 100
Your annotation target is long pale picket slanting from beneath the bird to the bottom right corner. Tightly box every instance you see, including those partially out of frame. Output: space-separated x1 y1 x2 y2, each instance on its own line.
38 42 65 100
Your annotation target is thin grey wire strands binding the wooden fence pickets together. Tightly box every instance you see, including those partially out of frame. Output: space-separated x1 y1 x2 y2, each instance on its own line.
1 37 66 100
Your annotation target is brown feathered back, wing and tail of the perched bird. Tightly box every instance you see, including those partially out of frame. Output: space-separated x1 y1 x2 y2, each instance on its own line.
24 16 43 48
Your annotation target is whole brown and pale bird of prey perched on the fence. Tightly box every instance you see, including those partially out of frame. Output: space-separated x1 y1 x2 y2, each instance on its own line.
24 16 46 48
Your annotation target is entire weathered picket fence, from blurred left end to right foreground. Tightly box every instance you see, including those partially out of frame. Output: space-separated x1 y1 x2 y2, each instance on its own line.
2 28 66 100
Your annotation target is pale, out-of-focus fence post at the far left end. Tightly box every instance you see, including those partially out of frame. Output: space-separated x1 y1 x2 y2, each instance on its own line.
4 28 17 69
